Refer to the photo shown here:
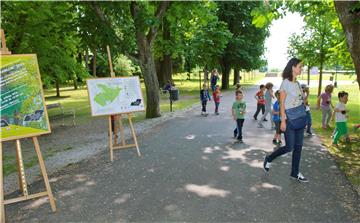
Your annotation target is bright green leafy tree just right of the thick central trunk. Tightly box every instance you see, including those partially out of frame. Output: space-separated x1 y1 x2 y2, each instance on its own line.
154 2 231 84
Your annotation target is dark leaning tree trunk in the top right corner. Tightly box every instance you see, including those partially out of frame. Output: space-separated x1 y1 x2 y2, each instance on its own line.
334 1 360 89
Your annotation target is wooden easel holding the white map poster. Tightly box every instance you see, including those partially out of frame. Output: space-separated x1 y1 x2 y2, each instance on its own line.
106 46 141 162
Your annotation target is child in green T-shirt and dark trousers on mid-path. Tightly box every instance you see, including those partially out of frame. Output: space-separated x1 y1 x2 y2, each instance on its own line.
232 90 246 143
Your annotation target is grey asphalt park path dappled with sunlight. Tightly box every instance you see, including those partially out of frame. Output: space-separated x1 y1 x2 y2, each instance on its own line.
6 78 360 222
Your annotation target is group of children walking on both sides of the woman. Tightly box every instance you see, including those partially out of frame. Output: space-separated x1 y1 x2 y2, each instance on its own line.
232 82 349 146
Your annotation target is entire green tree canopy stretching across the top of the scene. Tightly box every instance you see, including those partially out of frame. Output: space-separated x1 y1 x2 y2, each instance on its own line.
1 1 360 118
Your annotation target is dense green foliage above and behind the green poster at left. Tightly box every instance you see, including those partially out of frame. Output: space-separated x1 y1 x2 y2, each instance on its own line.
2 2 86 89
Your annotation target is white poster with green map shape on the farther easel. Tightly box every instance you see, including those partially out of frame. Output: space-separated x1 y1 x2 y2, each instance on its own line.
86 77 144 116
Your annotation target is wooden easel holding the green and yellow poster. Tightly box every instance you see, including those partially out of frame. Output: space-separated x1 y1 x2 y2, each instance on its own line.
0 29 56 223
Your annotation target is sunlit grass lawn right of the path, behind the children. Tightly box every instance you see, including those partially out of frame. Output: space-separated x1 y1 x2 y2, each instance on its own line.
310 84 360 188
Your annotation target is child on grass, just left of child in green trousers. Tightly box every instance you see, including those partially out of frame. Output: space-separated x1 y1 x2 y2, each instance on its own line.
317 84 334 129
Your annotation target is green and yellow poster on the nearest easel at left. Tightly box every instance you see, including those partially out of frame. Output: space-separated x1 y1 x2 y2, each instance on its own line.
0 54 50 141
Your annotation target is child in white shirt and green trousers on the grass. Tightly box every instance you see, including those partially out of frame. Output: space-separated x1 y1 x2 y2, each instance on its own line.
332 91 349 146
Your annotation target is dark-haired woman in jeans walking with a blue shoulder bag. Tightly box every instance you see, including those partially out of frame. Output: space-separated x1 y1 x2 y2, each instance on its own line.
263 58 308 182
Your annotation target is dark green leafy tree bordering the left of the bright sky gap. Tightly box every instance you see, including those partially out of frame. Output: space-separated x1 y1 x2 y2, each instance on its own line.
217 2 269 89
